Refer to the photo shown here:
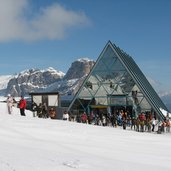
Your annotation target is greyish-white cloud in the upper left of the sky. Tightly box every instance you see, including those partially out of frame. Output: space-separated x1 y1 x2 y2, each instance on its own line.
0 0 89 42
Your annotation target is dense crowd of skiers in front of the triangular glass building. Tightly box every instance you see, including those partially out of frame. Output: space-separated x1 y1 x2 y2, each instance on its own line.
70 110 171 134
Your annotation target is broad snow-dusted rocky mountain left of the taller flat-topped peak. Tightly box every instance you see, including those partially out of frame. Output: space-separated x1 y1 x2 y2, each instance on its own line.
5 67 65 96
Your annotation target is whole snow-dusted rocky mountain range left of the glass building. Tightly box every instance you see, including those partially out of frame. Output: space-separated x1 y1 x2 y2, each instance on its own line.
0 58 95 96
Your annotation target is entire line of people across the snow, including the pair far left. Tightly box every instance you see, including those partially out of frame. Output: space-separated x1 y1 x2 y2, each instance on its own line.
6 94 171 133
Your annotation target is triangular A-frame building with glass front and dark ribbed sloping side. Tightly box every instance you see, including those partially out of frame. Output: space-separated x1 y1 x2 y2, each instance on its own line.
68 41 168 120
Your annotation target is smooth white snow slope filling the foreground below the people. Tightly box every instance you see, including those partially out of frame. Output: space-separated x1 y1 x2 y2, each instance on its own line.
0 102 171 171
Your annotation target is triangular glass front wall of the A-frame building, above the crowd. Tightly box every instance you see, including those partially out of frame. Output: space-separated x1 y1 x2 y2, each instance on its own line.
69 40 168 120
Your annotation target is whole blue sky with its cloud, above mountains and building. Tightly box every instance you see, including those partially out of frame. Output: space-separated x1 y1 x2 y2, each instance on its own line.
0 0 171 88
